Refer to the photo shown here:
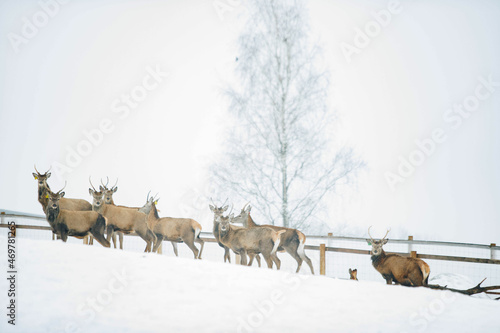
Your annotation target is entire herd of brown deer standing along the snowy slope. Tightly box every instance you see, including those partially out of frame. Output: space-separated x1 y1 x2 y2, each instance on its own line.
33 166 430 286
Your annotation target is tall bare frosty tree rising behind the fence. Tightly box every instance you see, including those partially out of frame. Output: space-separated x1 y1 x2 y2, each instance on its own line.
212 0 362 228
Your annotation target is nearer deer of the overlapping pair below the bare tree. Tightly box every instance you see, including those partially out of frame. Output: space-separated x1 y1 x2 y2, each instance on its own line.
217 214 286 270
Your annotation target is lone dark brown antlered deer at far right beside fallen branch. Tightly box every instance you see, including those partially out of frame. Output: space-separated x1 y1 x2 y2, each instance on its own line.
366 226 431 287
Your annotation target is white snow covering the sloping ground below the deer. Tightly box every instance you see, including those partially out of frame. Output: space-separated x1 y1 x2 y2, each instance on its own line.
0 236 500 333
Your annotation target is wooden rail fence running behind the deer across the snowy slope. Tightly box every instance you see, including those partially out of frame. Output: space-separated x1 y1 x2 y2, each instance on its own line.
0 212 500 275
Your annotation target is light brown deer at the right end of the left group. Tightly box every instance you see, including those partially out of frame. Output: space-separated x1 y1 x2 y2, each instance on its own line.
139 197 205 259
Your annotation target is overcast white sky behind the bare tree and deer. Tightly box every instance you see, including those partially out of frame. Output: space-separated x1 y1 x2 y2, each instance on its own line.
0 0 500 244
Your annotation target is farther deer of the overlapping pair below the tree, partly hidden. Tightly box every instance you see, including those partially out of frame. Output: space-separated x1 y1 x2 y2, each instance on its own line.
234 203 314 275
